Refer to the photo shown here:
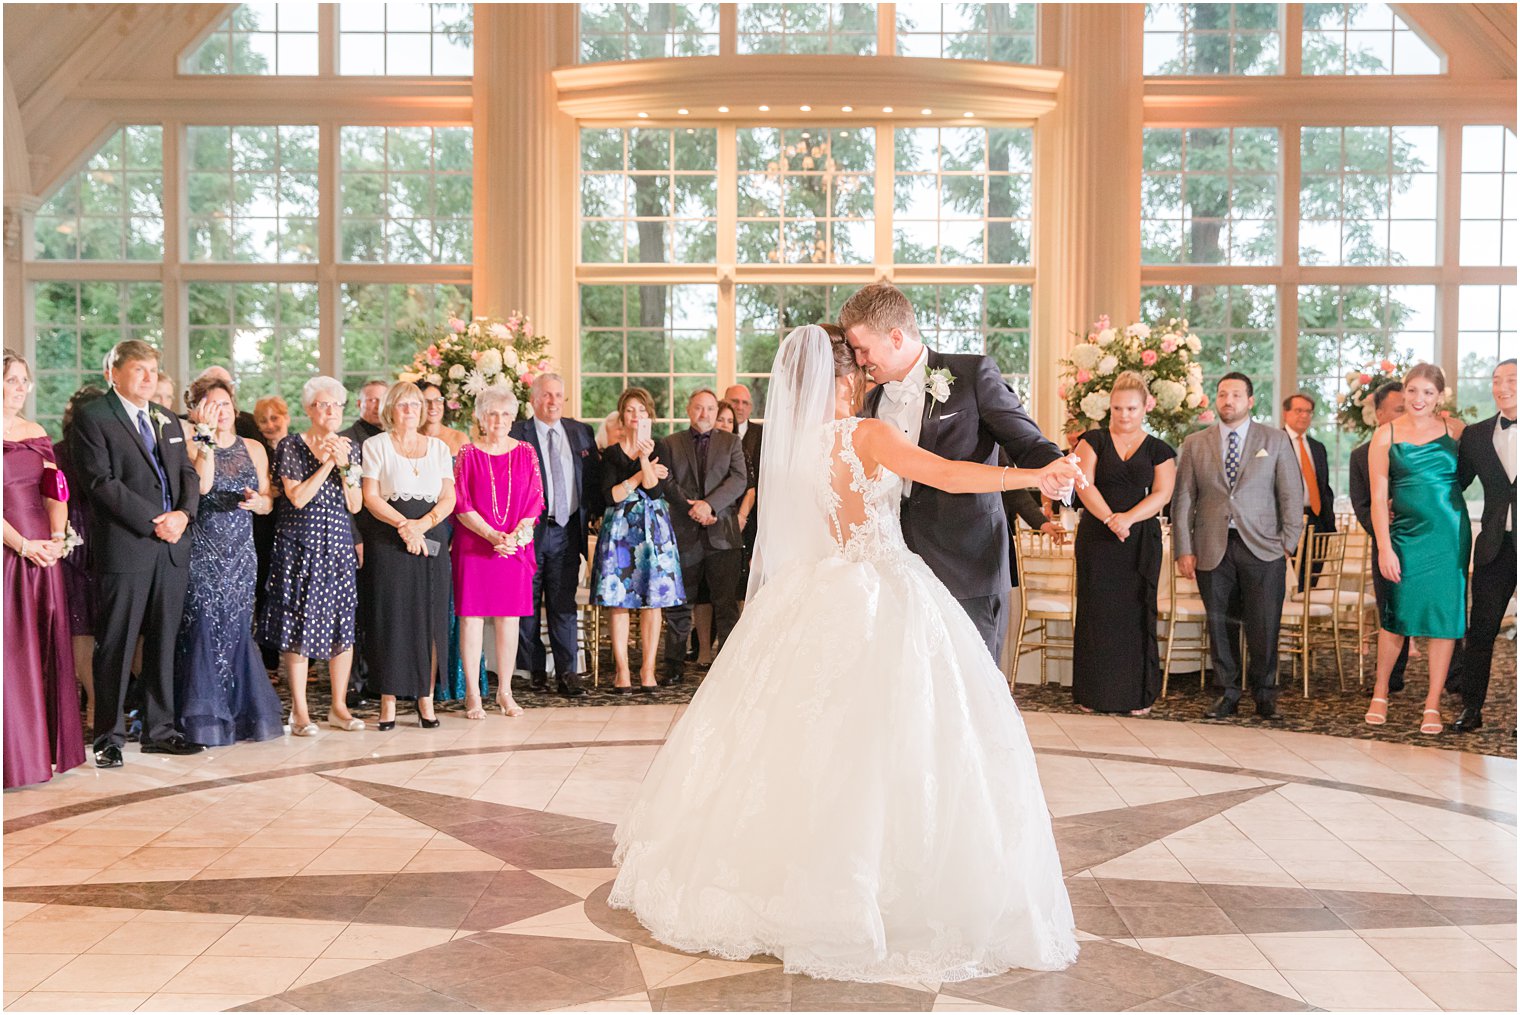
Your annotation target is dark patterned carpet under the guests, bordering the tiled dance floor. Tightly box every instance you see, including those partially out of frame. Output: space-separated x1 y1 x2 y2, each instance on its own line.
270 632 1515 758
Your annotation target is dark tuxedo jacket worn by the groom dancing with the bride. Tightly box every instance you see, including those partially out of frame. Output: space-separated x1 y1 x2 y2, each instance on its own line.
865 349 1061 599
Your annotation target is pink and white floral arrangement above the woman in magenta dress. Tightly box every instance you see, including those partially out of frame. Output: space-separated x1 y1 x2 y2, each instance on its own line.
397 310 553 432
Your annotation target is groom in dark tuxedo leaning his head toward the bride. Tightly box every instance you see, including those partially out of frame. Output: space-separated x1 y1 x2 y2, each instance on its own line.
839 283 1067 659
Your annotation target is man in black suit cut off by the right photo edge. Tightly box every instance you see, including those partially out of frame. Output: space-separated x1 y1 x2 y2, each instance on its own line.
1452 360 1515 732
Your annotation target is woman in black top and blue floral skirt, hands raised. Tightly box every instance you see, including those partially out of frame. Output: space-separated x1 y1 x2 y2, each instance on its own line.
591 387 686 694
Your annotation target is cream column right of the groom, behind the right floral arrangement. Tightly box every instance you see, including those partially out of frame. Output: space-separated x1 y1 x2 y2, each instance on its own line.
1031 3 1145 436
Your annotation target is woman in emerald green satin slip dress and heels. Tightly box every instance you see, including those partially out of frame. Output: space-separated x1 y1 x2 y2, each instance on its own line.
1366 363 1473 734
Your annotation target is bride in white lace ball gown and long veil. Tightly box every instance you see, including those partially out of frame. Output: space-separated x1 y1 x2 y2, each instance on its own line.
610 325 1081 982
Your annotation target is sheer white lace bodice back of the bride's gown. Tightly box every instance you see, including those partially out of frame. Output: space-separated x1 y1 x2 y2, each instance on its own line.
824 418 907 561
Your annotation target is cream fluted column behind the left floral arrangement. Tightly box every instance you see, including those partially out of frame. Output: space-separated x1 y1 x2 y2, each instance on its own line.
474 3 576 374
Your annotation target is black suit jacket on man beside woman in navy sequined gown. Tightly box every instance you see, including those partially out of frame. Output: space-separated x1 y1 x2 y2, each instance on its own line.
73 392 201 573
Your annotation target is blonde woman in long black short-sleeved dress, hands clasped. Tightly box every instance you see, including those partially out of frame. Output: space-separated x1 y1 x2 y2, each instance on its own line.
1072 371 1176 716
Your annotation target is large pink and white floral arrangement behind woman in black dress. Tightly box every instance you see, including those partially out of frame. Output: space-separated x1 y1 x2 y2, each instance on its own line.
1056 315 1214 444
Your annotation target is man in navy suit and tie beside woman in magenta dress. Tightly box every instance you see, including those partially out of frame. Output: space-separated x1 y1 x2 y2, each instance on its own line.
513 374 602 697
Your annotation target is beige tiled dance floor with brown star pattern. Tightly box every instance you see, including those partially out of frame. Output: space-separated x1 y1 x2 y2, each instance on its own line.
5 705 1515 1010
